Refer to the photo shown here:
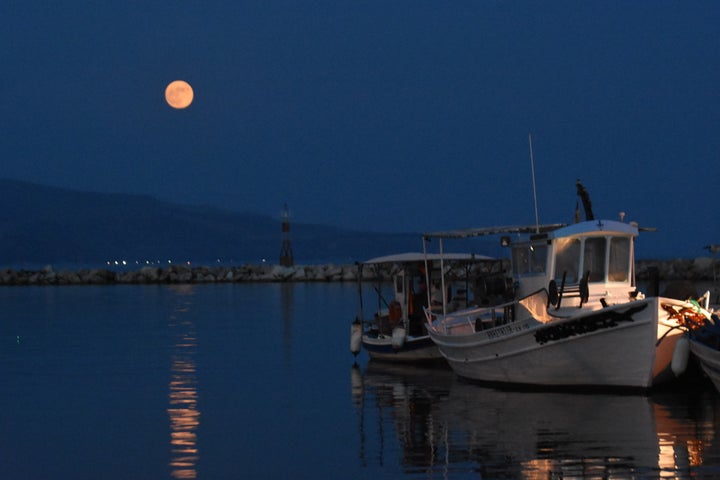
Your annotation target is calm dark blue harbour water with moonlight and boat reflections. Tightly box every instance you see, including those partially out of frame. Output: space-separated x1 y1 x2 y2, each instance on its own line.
0 284 720 480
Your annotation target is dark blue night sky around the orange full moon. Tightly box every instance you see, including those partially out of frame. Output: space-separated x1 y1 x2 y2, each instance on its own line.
0 0 720 258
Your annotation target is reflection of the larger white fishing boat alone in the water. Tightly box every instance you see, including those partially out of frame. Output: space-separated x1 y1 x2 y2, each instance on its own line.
434 382 714 478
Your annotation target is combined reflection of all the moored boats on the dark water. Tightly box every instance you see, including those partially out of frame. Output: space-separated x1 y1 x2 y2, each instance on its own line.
354 365 720 479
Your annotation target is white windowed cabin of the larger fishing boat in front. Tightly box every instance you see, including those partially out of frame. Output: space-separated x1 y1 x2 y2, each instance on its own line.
510 220 638 309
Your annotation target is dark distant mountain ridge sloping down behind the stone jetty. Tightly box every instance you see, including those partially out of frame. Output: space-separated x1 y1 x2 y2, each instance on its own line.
0 179 421 266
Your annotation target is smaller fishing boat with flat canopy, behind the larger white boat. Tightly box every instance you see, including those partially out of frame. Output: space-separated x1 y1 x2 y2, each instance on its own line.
350 252 505 362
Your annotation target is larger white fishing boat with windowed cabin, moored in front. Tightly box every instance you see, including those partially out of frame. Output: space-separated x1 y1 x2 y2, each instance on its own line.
425 214 704 389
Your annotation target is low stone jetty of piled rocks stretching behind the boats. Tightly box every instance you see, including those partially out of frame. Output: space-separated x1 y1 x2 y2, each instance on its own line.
0 258 720 286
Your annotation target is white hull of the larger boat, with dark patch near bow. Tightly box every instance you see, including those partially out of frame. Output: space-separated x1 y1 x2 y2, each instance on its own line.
430 298 681 388
